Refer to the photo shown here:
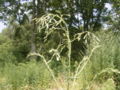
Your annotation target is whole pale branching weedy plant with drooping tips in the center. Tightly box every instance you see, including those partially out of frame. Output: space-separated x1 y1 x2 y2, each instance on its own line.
28 13 119 90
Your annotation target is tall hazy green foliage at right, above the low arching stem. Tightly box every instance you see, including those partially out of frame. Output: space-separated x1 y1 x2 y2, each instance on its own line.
92 31 120 71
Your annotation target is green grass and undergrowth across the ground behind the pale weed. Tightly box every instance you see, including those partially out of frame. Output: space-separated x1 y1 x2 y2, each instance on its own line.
0 31 120 90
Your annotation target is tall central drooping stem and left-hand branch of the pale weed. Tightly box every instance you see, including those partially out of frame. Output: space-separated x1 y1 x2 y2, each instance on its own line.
30 14 72 87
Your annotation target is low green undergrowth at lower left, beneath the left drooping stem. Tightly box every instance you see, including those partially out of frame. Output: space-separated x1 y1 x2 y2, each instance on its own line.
0 61 51 90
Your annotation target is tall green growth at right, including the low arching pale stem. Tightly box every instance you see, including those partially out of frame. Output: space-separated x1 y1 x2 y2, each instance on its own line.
87 31 120 90
